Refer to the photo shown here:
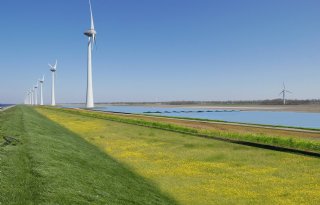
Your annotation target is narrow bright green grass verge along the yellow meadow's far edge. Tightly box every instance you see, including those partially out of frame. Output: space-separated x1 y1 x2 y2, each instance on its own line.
46 107 320 153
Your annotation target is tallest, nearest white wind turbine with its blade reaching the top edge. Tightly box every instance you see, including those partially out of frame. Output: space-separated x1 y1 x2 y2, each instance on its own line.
84 0 97 108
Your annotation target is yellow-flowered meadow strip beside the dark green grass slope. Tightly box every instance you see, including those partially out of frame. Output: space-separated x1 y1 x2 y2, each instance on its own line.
37 108 320 205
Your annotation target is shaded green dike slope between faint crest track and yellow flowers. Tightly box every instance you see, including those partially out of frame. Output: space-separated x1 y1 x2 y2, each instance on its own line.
0 106 177 205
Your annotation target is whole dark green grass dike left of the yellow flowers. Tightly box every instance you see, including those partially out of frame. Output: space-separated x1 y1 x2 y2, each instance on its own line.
0 106 176 205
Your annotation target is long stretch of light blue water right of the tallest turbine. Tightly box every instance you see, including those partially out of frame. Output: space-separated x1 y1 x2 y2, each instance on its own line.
84 106 320 128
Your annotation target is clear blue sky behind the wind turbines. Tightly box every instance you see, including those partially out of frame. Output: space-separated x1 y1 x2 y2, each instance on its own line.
0 0 320 103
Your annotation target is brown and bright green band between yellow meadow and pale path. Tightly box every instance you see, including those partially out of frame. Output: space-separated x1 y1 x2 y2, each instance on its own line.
45 107 320 153
